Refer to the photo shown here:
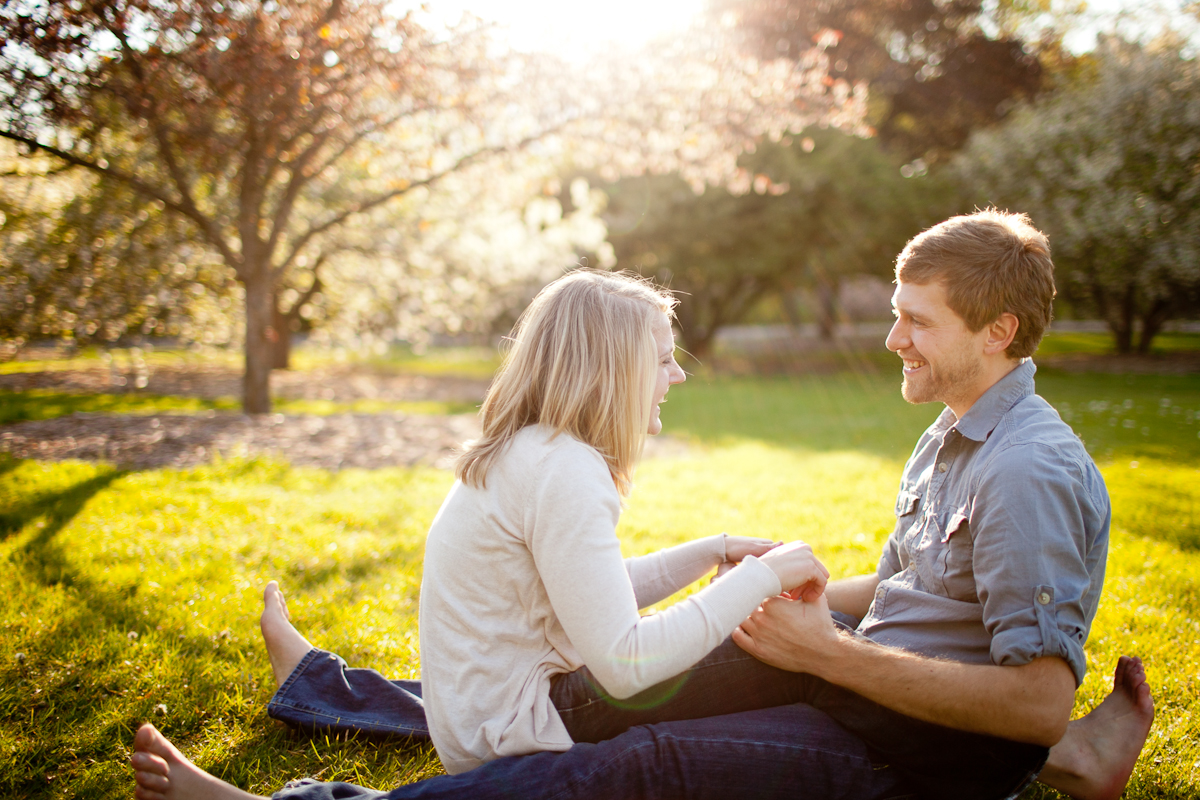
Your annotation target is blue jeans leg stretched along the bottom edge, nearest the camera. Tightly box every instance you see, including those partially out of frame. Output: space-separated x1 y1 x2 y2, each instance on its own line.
274 704 914 800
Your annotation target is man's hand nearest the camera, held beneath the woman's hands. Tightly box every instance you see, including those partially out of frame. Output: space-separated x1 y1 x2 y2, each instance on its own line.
733 594 841 675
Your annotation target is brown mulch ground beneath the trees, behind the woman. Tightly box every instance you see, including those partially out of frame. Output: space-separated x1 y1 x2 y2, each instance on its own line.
0 367 688 470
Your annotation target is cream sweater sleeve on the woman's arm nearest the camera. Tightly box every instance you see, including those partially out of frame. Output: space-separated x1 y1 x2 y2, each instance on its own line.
524 441 781 699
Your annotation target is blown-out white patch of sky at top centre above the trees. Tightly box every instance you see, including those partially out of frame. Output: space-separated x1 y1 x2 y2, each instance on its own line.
431 0 704 58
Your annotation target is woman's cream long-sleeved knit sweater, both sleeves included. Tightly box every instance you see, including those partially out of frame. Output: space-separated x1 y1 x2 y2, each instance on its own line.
420 426 780 774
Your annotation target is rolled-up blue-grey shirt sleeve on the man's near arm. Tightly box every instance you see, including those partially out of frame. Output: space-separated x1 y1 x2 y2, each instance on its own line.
970 443 1100 686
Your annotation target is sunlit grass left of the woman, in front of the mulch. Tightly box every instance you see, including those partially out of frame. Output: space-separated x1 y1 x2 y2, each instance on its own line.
0 461 450 798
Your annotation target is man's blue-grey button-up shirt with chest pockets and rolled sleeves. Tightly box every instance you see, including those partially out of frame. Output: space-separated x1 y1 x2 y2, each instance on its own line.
858 360 1111 684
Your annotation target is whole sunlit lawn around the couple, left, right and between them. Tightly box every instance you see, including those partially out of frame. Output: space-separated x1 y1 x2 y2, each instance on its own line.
0 357 1200 799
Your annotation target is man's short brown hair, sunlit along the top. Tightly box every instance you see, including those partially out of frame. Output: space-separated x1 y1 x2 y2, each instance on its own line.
896 209 1055 359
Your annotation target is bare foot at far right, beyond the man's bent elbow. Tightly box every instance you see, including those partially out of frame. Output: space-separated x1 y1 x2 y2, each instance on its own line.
1038 656 1154 800
